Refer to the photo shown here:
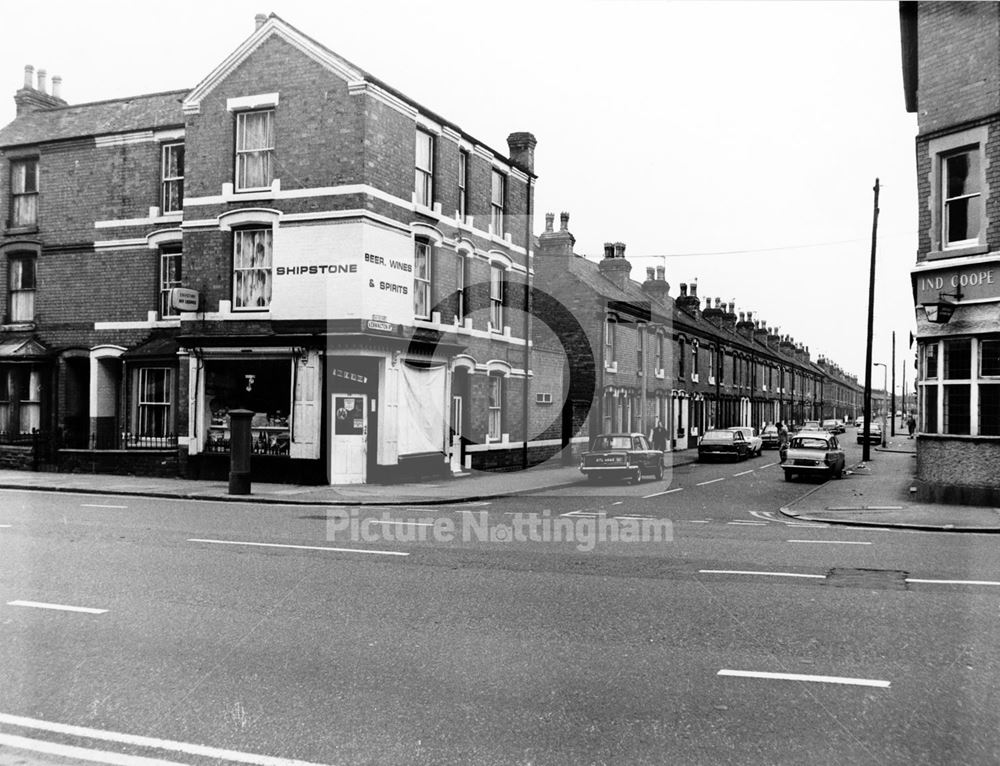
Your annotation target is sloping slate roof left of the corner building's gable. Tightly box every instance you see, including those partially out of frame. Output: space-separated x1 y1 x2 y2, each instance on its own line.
0 90 188 147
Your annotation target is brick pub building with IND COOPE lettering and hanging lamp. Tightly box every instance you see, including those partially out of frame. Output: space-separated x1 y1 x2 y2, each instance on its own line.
900 2 1000 505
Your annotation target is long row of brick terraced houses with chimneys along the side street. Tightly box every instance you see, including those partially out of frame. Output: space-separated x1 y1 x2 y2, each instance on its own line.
535 213 861 450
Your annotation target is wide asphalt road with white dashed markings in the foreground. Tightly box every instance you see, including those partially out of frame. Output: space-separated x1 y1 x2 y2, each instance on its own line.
0 431 1000 766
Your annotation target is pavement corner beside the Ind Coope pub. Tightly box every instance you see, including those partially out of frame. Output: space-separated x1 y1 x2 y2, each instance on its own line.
780 434 1000 533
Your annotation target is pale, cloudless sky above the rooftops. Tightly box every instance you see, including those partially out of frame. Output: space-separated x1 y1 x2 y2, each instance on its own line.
0 0 917 390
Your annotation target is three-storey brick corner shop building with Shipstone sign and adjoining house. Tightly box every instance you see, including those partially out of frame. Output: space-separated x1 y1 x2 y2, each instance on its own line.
0 14 563 483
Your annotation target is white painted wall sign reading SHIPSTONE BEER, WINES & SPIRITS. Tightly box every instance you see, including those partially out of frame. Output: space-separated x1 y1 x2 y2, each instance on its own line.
271 221 413 325
